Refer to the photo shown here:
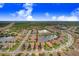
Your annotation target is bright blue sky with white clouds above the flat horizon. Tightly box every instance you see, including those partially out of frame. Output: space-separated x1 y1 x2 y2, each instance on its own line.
0 3 79 21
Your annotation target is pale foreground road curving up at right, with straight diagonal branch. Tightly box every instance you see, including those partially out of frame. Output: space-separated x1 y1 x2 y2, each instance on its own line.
0 30 73 55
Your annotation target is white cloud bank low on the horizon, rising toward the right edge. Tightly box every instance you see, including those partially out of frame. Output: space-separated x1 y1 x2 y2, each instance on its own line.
52 8 79 21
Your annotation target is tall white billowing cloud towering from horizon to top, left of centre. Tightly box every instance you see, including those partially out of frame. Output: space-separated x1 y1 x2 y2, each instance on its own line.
12 3 33 21
